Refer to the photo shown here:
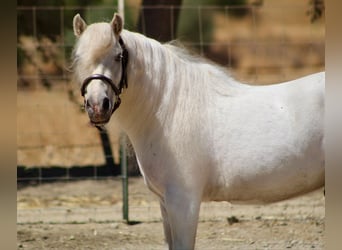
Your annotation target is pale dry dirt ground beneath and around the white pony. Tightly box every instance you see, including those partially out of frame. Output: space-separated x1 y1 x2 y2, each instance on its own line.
17 177 325 250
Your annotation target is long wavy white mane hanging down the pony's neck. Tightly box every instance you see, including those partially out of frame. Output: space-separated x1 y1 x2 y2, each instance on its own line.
105 30 251 136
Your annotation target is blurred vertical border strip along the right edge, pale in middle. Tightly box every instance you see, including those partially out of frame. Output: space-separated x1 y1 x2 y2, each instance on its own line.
325 0 342 250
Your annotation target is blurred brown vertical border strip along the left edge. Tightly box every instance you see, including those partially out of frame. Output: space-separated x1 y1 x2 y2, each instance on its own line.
0 1 17 249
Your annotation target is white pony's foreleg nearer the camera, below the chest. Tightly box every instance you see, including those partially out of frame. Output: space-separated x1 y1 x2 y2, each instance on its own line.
164 186 200 250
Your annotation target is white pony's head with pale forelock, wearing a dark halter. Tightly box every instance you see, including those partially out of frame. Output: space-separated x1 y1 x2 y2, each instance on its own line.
73 14 128 126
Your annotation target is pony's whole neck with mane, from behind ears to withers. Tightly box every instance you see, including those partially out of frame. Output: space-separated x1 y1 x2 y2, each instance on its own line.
114 30 246 142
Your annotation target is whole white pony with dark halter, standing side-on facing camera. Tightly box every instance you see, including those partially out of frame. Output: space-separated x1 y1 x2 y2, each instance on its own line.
73 14 325 249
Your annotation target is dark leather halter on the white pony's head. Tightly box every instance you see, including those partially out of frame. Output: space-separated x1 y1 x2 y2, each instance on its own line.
81 37 128 113
